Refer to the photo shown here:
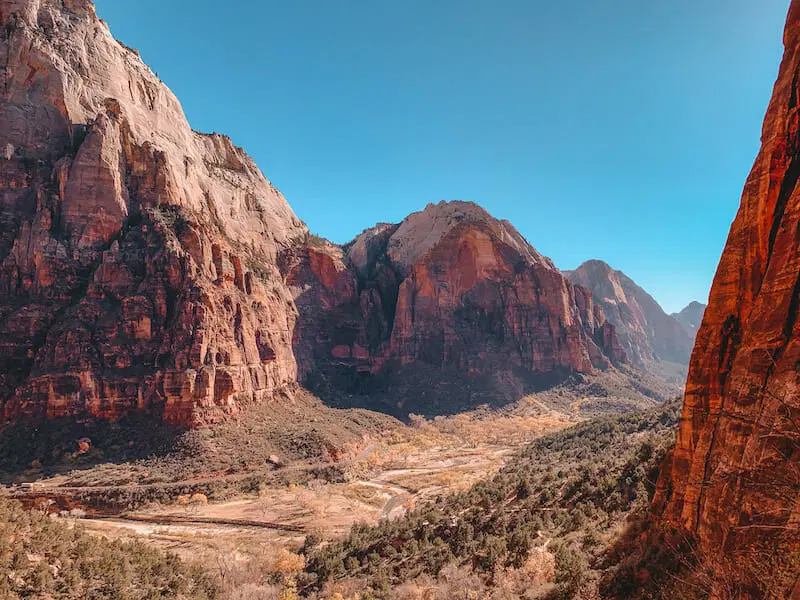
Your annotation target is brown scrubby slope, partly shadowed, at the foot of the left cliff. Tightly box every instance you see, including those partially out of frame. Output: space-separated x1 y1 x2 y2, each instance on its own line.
0 390 400 494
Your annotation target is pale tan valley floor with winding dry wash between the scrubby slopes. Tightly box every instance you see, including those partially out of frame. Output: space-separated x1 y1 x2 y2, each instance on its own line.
0 398 575 597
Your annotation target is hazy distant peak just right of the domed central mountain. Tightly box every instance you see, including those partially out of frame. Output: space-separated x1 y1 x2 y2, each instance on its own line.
564 260 692 367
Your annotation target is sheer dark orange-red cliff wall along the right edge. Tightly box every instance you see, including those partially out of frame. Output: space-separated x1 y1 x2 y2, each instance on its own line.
655 0 800 598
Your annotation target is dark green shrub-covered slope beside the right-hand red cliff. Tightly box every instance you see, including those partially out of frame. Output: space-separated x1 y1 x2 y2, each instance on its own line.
307 401 679 597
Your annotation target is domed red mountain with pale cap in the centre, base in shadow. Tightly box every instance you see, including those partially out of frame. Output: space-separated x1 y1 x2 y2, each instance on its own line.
288 202 625 412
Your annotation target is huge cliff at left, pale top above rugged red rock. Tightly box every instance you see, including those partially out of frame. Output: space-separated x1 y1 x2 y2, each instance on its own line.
0 0 306 425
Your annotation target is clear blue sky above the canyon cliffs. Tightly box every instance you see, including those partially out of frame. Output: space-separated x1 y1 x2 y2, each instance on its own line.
96 0 789 311
